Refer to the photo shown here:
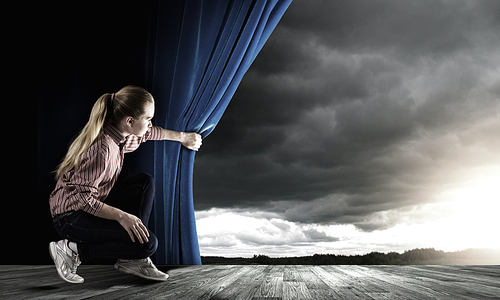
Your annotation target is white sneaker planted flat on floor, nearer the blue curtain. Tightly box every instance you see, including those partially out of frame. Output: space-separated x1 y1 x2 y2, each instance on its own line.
115 257 168 281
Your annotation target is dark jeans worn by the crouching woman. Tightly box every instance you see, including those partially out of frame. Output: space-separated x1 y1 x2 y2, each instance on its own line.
55 173 158 261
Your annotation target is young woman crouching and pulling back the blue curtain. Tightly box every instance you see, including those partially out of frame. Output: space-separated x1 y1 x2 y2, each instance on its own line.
49 86 201 283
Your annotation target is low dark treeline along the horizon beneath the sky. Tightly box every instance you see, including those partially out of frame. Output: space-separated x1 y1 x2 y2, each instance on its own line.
201 248 500 265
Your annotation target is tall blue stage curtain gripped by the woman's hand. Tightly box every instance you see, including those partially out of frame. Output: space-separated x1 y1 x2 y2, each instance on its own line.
140 0 291 265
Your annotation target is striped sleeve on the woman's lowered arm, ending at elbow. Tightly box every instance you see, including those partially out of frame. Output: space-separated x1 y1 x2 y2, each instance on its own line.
66 151 107 215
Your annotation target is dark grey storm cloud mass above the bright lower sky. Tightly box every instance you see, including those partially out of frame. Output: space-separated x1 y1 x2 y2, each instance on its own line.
195 0 500 230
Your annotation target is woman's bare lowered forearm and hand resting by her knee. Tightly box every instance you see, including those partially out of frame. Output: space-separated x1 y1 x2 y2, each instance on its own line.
97 203 149 244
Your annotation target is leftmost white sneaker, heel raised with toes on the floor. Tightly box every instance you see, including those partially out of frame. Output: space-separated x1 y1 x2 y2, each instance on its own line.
49 240 83 283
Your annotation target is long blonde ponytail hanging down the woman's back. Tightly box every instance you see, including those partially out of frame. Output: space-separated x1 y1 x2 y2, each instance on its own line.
56 94 112 179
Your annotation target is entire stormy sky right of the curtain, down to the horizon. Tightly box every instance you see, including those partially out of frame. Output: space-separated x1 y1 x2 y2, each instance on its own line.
194 0 500 256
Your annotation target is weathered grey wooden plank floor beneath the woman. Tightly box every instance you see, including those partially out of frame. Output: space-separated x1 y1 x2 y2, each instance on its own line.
0 265 500 300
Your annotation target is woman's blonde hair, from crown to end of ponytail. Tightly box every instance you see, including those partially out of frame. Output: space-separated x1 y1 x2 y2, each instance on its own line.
55 85 154 180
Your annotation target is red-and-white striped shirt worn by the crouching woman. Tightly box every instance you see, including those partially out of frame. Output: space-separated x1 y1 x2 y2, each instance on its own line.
50 123 163 217
